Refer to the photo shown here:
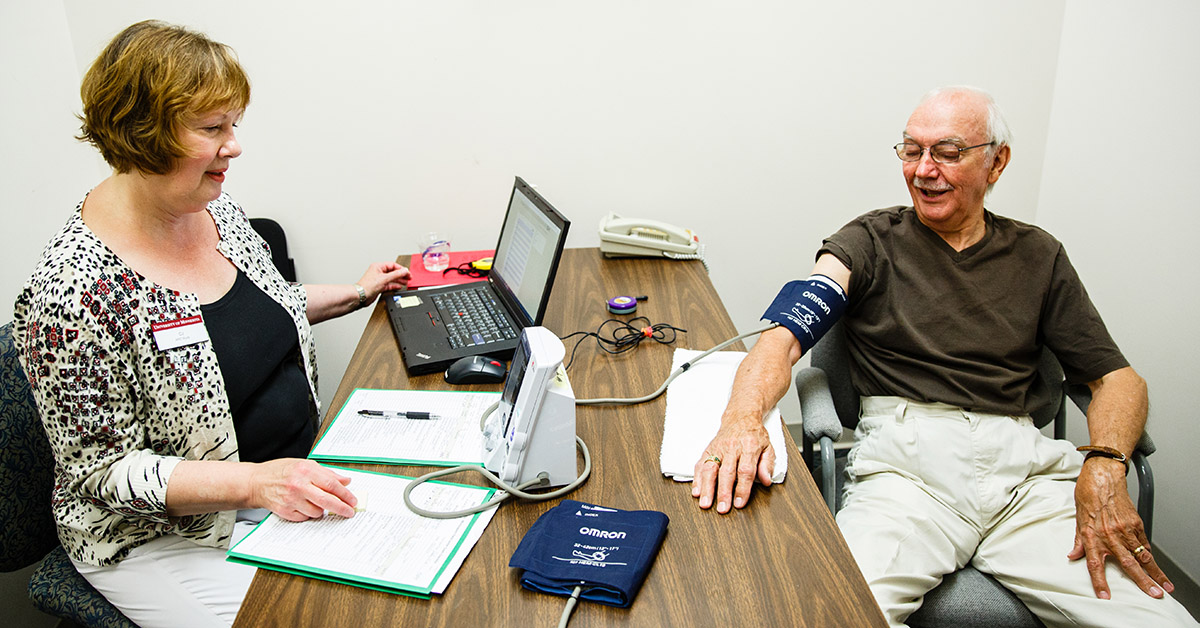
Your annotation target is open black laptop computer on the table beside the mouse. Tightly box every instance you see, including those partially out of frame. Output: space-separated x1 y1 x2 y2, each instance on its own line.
384 177 571 375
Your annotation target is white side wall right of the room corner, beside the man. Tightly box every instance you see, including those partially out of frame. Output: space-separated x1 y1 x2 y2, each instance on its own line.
1038 0 1200 580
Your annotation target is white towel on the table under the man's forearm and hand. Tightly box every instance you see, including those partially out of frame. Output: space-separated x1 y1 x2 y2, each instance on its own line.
659 348 787 482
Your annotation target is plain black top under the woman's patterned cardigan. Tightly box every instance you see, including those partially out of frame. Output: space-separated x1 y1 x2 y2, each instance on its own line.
200 270 316 462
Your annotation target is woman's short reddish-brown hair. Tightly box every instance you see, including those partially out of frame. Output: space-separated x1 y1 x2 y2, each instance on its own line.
78 19 250 174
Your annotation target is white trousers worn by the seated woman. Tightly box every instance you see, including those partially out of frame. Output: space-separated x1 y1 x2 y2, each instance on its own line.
72 513 263 628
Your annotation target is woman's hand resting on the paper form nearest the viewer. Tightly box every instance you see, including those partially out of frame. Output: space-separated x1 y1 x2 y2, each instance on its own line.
251 457 358 521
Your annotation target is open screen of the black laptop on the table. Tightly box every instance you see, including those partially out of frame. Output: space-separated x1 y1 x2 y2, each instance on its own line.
491 178 566 324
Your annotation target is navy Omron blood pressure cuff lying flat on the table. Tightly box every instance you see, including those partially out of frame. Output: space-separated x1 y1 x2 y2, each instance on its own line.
509 500 668 608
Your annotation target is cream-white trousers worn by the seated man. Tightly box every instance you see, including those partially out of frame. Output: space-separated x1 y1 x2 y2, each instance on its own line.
838 397 1196 627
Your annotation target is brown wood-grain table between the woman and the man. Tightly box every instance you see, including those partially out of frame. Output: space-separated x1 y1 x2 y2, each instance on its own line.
234 249 886 628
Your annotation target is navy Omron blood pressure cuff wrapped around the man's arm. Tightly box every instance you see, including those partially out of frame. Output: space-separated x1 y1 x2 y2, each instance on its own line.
762 275 846 353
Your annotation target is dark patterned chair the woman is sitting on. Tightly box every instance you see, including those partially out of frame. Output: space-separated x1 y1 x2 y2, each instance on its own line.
0 323 137 628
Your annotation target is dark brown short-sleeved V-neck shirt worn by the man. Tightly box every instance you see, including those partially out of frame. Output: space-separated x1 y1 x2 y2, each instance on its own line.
817 207 1129 414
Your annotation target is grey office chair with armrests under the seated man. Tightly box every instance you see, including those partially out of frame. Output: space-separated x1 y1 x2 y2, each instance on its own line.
796 323 1154 628
